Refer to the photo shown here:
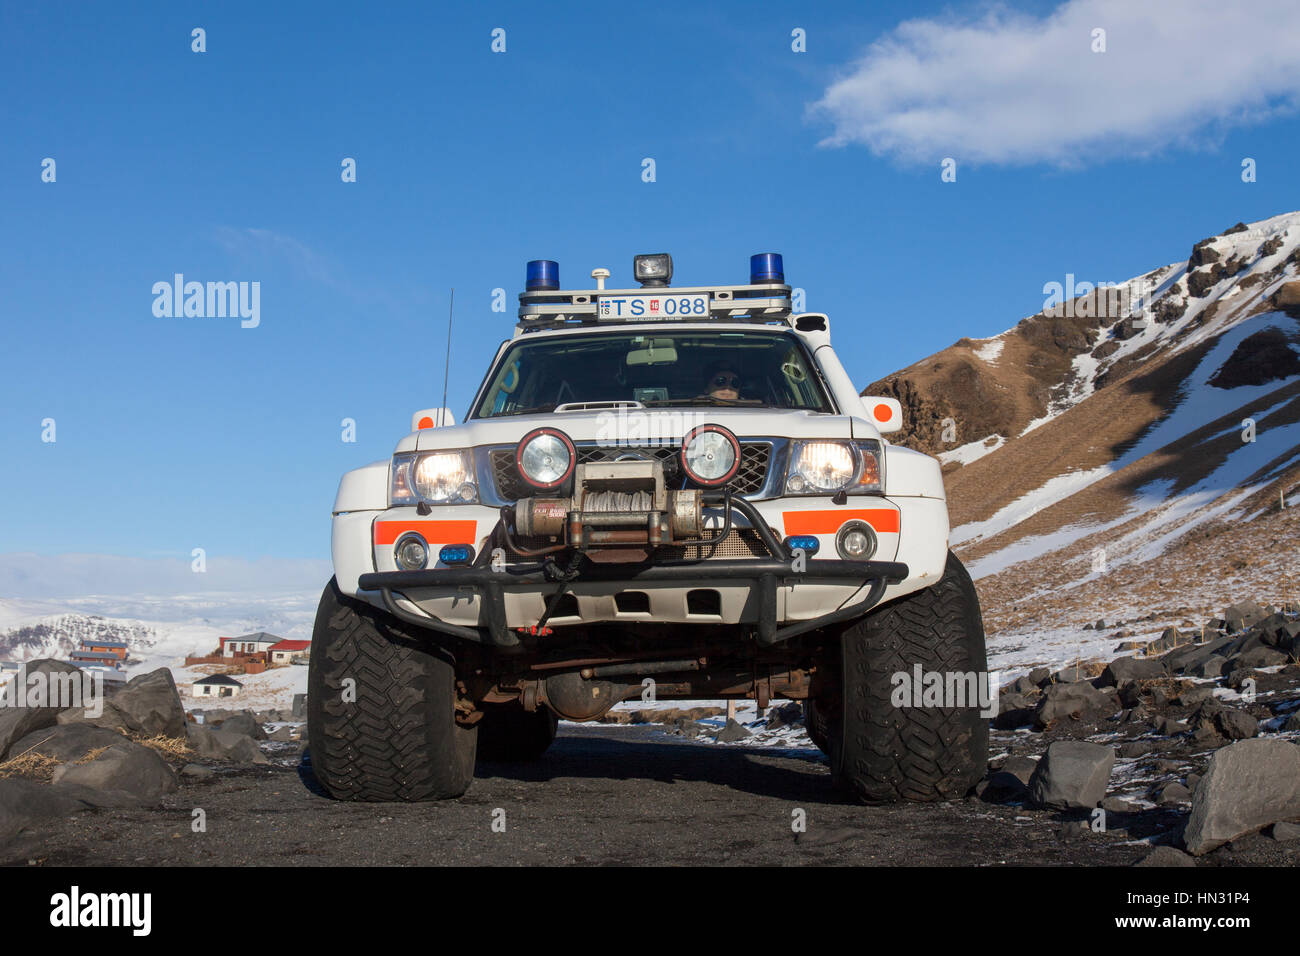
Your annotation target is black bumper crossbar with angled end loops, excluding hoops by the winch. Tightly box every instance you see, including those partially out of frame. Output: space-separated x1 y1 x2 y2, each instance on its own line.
358 558 909 649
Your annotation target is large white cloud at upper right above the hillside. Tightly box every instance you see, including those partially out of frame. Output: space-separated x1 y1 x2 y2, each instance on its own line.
809 0 1300 166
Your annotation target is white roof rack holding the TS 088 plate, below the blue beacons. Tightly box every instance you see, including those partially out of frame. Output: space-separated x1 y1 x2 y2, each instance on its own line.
519 282 792 332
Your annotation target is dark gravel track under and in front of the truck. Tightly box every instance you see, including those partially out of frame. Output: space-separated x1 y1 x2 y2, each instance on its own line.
0 724 1196 866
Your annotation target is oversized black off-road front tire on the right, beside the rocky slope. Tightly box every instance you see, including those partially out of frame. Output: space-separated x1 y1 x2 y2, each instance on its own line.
827 553 988 803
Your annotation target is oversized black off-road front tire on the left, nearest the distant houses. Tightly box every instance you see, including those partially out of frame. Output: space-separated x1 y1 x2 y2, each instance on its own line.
307 579 478 801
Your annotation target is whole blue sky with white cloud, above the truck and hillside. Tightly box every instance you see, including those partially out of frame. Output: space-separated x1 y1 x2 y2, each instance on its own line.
0 0 1300 580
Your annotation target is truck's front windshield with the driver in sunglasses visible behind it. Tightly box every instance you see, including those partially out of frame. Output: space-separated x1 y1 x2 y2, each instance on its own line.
473 330 833 419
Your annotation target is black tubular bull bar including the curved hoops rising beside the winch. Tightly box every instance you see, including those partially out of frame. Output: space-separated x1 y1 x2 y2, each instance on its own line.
358 494 909 650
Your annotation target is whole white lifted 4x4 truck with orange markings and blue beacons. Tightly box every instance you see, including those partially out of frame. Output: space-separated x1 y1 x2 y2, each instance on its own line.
308 254 988 803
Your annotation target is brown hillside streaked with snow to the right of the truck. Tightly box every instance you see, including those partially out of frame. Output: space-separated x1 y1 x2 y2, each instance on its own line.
867 213 1300 642
